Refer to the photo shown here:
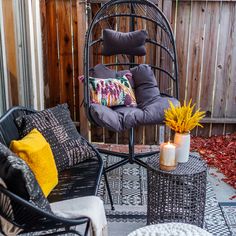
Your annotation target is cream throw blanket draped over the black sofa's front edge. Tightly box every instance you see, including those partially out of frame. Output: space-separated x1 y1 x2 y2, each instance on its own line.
50 196 108 236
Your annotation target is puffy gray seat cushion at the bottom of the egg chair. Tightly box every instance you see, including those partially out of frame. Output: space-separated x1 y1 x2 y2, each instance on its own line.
90 95 179 132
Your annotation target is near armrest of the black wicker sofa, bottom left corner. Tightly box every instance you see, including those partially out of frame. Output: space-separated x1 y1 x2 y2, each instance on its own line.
0 186 89 232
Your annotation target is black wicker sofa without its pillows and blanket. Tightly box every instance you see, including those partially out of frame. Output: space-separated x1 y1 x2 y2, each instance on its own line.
0 107 106 235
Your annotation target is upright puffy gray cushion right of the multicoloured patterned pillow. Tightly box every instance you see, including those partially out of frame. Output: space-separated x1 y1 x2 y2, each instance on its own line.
130 64 160 108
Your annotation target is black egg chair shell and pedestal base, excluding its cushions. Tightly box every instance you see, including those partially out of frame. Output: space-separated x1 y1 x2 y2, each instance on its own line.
84 0 178 209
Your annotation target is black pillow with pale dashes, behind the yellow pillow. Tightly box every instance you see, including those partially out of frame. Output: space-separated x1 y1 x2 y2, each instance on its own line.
16 104 96 171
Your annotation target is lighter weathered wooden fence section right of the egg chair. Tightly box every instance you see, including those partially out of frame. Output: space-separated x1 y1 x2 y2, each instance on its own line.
172 0 236 136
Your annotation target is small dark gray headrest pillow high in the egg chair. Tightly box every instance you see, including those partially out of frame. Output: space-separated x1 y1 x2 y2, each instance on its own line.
102 29 148 56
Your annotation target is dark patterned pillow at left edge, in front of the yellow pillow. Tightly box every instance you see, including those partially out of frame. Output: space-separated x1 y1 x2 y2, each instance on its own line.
0 143 52 213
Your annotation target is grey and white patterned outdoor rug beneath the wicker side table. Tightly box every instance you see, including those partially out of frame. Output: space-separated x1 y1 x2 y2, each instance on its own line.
99 156 232 236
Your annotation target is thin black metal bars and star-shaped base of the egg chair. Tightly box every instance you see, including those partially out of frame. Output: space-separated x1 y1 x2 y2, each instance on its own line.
84 0 179 209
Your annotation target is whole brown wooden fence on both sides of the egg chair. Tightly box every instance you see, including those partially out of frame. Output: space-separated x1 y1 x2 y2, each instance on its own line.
41 0 236 144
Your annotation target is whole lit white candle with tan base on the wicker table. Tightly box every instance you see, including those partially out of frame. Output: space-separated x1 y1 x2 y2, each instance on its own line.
160 142 176 171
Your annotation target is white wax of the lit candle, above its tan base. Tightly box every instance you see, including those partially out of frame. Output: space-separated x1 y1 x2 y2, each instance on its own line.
160 143 176 166
